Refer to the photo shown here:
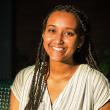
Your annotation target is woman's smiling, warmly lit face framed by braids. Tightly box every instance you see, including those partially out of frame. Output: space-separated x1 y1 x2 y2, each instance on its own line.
43 11 79 63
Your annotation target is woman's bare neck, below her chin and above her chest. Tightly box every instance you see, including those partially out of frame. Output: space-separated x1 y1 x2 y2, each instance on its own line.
49 61 77 79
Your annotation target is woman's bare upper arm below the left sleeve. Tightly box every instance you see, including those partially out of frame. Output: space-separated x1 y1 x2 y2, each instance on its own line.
10 91 19 110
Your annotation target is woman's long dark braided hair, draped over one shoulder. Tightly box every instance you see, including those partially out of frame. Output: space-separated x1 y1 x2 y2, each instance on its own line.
25 5 97 110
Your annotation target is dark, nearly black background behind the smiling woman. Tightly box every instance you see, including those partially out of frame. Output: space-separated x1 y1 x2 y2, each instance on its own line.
0 0 110 80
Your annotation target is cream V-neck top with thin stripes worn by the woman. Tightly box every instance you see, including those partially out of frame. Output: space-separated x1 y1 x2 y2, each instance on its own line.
11 64 110 110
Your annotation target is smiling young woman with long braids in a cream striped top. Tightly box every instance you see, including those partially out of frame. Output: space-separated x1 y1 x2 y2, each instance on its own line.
10 5 110 110
